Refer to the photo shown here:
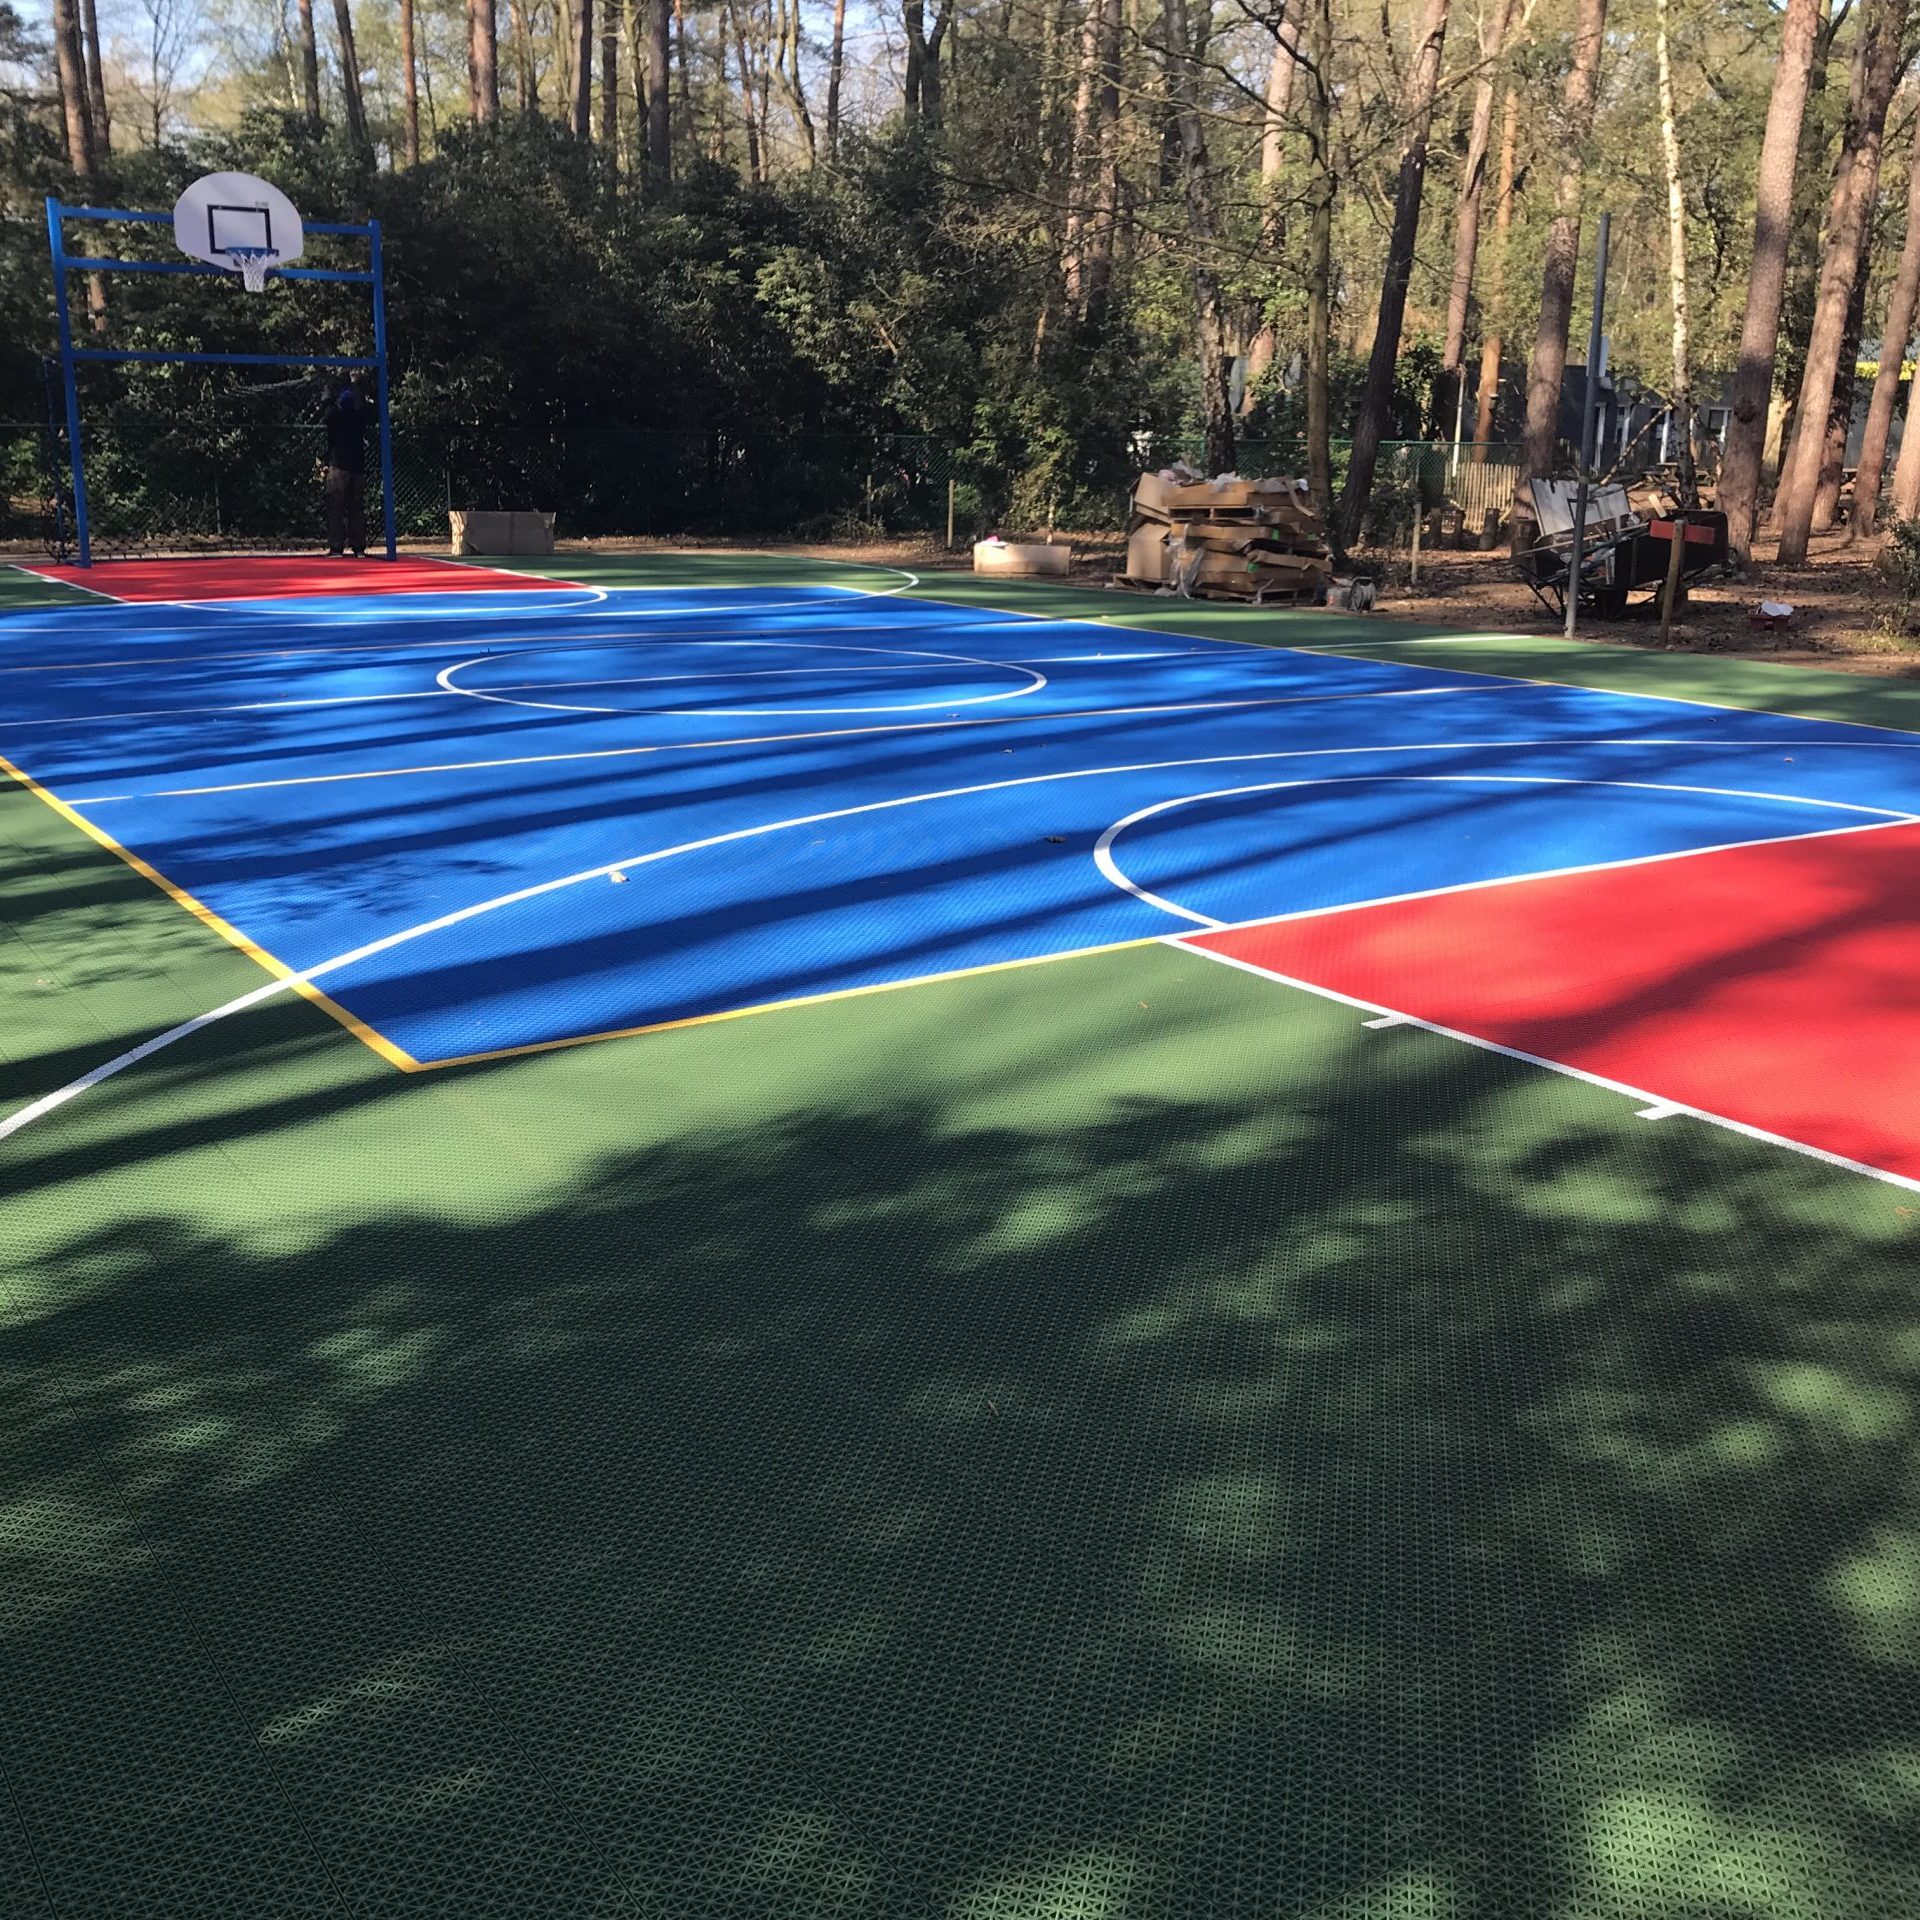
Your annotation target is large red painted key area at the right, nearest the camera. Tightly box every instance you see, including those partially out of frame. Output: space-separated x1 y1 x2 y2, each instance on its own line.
1187 826 1920 1181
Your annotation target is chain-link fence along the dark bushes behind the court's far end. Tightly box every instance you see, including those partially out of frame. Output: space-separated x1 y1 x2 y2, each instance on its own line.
0 417 1517 553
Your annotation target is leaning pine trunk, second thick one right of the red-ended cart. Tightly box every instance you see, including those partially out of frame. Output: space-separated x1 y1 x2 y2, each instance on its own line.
1778 0 1907 566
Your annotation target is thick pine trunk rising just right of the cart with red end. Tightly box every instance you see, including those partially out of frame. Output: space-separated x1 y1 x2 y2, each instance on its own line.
1715 0 1820 566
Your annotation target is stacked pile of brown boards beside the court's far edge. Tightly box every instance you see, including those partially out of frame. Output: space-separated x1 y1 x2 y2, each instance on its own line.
1119 465 1332 605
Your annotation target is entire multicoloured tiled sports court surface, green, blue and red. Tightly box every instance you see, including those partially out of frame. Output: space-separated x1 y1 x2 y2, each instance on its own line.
0 559 1920 1920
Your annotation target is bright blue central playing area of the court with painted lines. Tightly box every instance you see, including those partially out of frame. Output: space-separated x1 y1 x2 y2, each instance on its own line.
0 588 1920 1064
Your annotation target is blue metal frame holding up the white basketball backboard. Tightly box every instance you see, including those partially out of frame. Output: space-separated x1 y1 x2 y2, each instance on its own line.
46 194 399 566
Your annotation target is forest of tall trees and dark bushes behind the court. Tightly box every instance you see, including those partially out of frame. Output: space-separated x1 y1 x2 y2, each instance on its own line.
0 0 1920 559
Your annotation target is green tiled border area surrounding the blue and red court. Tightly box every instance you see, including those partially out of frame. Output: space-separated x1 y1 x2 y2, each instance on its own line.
0 555 1920 1920
